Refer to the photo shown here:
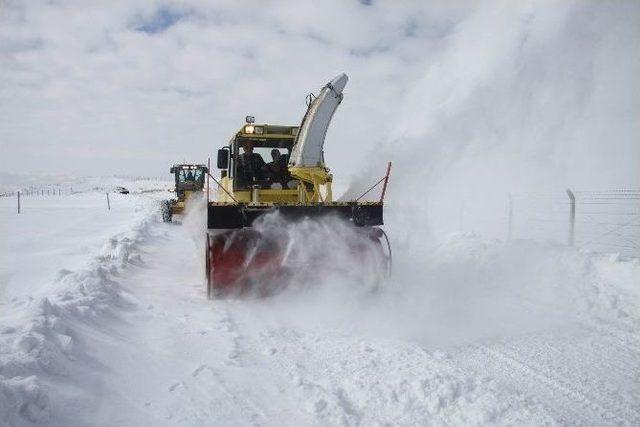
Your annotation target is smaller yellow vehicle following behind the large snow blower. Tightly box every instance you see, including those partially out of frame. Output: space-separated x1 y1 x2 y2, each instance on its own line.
161 164 209 222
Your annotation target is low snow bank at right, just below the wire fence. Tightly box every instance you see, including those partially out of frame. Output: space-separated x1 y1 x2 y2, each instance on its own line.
432 234 640 320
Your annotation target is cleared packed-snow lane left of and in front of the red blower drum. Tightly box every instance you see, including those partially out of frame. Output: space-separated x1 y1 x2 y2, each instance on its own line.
86 219 544 425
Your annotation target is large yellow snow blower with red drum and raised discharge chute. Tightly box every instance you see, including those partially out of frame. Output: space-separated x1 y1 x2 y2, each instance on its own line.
206 74 391 298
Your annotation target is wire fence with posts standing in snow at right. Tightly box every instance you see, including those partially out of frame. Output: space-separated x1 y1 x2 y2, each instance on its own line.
508 189 640 257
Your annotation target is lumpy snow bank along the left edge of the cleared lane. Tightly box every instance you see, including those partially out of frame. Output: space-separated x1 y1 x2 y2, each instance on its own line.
0 201 157 425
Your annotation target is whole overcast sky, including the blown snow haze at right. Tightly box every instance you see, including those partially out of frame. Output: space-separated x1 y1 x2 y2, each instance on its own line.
0 0 640 212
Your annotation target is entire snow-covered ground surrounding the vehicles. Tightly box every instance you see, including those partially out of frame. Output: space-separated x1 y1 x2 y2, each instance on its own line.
0 182 640 426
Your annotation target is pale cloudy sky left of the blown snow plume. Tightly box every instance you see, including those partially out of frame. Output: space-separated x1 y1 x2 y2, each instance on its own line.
0 1 464 177
